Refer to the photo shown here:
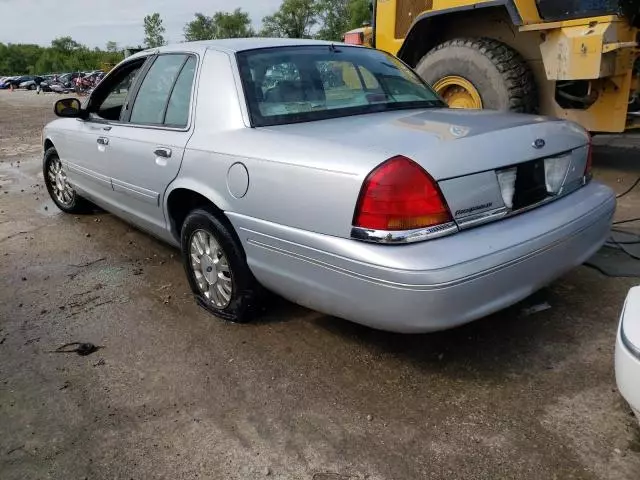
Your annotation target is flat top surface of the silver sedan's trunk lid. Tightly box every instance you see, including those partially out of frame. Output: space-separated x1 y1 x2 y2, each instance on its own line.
258 109 588 180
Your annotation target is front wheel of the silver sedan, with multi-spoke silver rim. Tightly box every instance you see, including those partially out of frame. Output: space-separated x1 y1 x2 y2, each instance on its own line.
42 147 94 214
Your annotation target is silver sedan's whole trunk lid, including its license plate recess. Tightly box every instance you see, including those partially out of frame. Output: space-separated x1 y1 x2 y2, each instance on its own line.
262 109 589 237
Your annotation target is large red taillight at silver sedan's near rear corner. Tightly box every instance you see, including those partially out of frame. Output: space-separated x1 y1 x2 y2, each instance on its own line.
353 156 452 230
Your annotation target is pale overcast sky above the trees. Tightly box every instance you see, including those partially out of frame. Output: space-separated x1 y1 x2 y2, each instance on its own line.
0 0 282 48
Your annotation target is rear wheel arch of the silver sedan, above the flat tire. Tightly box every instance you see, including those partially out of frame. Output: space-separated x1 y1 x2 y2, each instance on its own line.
164 181 233 242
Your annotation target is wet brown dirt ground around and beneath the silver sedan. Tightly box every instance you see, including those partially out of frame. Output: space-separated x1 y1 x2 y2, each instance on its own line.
0 92 640 480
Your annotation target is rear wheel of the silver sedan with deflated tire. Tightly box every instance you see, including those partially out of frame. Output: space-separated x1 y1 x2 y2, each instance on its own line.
181 209 259 323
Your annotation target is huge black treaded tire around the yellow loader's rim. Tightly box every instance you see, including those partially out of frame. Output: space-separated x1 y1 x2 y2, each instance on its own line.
416 38 538 113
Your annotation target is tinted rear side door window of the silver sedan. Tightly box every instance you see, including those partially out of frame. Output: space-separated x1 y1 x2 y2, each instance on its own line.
129 54 193 125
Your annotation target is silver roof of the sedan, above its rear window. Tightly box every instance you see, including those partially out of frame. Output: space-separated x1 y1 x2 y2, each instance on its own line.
129 37 353 58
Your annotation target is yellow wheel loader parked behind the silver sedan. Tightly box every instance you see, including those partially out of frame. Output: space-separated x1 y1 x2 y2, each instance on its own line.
344 0 640 132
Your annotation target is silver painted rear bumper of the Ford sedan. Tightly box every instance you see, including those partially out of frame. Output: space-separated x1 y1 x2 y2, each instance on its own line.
229 182 615 333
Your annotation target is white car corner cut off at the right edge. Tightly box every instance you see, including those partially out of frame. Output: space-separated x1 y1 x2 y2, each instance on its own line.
616 287 640 421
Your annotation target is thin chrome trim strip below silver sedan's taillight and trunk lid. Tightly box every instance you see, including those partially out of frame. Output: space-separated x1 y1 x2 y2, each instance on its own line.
351 175 591 245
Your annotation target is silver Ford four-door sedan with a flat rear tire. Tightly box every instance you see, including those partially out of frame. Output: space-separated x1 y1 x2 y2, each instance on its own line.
43 39 615 332
